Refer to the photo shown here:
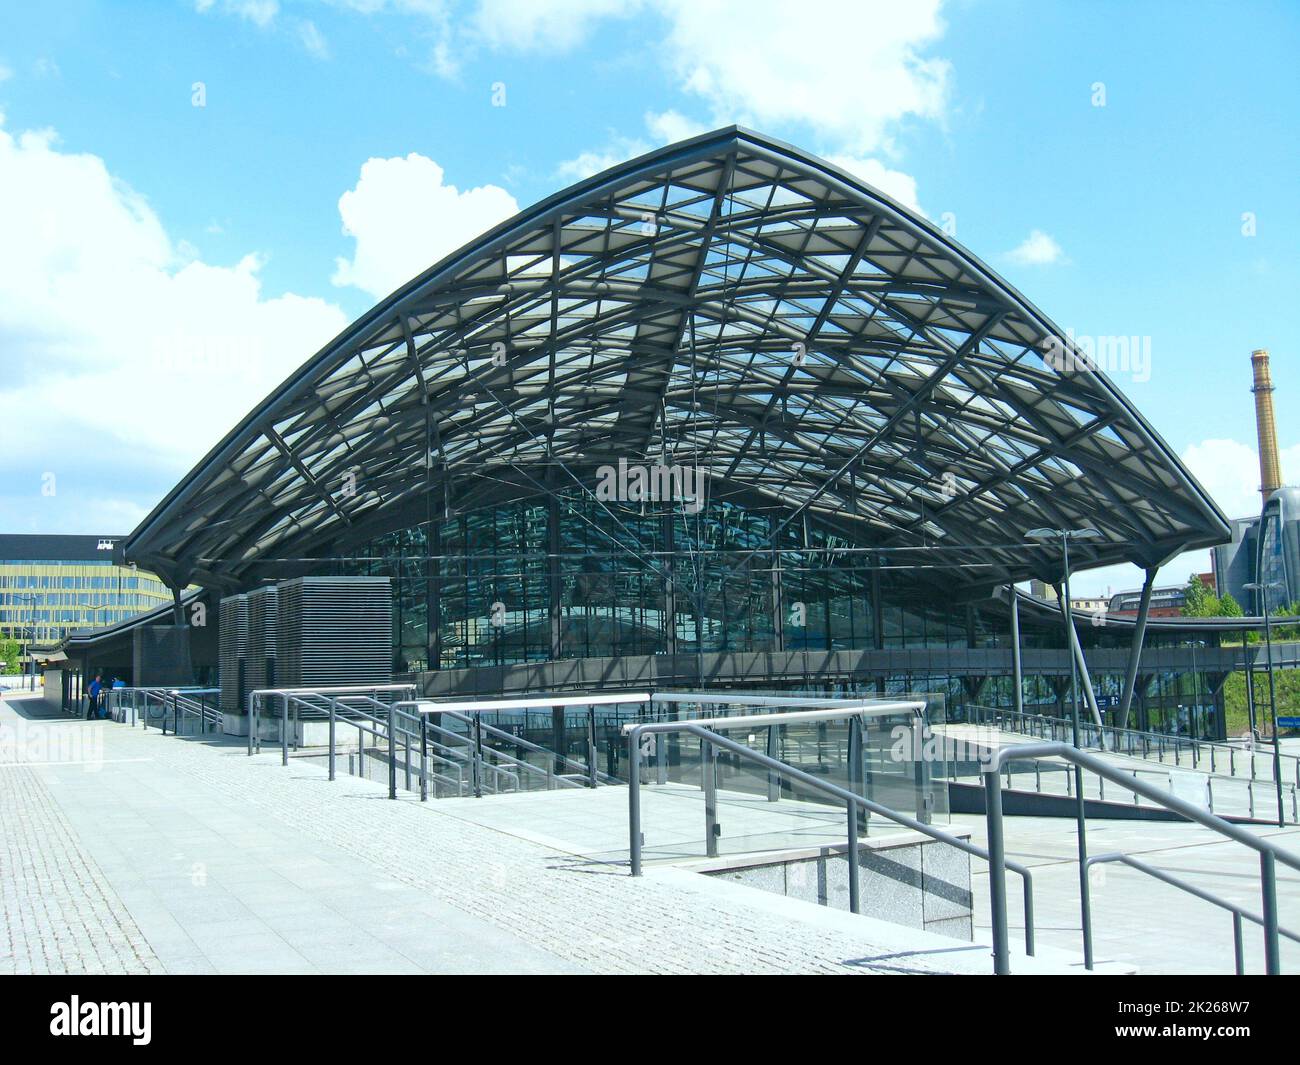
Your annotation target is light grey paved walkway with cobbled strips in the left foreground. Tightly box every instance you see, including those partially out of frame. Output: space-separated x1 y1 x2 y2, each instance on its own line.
0 698 1081 973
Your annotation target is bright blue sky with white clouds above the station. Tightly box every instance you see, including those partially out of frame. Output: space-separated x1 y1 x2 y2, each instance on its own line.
0 0 1300 590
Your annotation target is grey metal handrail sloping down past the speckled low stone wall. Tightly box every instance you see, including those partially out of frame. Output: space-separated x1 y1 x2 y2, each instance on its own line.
623 714 1034 956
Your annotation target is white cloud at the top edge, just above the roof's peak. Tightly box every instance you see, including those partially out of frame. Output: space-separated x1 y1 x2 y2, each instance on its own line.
664 0 952 155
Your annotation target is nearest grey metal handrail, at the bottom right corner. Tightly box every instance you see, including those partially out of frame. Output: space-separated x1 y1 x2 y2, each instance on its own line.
983 743 1300 975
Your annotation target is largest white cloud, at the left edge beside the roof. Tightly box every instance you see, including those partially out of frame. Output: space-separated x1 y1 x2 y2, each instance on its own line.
0 115 347 499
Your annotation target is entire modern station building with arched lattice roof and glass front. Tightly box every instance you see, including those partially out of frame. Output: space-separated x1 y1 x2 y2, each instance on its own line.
53 127 1279 736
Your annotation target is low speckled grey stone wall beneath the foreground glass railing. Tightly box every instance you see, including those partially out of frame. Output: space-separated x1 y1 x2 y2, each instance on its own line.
690 832 974 940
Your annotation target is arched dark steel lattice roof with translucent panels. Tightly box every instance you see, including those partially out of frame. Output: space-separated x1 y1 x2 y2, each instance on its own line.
125 127 1229 584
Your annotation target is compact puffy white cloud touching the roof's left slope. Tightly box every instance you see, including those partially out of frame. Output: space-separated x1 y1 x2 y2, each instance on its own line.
333 152 519 296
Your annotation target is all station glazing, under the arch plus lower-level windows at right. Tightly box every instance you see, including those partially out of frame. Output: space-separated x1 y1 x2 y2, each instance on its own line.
325 490 1222 735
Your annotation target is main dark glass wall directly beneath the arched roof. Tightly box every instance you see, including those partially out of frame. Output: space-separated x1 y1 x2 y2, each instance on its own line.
337 492 1001 672
